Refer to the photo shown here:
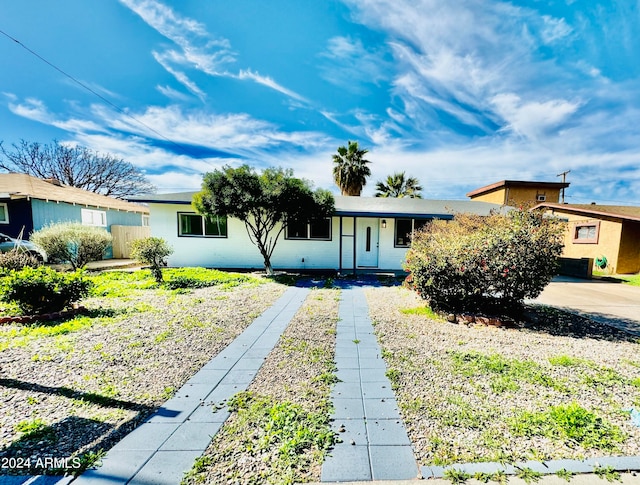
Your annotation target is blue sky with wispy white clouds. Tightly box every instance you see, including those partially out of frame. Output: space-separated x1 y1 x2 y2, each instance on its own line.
0 0 640 205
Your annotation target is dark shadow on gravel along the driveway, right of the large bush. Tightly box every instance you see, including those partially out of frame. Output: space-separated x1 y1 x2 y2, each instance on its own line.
521 305 638 343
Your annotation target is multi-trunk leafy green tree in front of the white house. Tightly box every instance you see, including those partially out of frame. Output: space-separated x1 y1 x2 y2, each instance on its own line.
193 165 334 275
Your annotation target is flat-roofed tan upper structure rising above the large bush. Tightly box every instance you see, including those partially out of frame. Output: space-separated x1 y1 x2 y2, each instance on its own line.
467 180 569 206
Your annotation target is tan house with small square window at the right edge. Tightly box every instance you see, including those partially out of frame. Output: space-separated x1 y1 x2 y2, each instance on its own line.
536 202 640 274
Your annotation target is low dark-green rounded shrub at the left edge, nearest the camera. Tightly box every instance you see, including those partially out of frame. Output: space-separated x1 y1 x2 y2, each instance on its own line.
0 266 91 315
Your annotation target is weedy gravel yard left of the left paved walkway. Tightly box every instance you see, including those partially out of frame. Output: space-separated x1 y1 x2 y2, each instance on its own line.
0 270 285 474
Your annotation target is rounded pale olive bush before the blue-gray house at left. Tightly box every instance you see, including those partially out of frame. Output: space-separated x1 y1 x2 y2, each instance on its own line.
30 222 113 271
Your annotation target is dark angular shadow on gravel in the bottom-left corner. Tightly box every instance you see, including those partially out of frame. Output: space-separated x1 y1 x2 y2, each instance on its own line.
0 379 156 474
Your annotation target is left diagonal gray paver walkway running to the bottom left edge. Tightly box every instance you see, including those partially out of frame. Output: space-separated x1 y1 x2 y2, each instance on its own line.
73 288 309 485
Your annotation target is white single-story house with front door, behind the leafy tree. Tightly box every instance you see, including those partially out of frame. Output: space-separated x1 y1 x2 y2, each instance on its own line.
132 192 501 273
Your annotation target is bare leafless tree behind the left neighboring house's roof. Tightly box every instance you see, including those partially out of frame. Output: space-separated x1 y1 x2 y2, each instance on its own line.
0 140 155 198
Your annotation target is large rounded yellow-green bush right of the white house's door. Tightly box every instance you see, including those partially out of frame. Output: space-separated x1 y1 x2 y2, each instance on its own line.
405 210 563 313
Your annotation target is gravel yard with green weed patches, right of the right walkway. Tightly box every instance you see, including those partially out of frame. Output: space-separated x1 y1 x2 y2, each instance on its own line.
366 287 640 465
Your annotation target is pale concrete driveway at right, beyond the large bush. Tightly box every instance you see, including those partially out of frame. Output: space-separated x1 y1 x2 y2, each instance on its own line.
528 276 640 336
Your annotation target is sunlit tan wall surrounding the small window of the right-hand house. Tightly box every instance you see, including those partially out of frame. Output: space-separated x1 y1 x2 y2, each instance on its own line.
555 211 622 272
